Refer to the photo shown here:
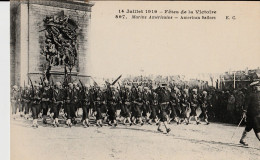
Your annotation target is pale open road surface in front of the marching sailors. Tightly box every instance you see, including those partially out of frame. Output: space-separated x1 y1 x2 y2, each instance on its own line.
11 119 260 160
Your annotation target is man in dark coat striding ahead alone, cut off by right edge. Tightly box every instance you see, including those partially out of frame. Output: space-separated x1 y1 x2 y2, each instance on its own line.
240 81 260 146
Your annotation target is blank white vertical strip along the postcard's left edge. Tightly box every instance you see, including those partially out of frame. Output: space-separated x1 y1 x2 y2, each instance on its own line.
0 2 10 160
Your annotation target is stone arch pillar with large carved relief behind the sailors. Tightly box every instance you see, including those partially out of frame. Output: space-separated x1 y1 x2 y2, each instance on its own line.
11 0 93 85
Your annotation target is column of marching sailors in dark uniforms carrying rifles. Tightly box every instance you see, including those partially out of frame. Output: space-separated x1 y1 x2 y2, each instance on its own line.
11 80 212 133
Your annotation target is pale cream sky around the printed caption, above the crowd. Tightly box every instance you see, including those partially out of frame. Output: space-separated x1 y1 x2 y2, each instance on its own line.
88 2 260 77
